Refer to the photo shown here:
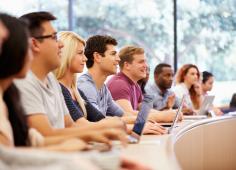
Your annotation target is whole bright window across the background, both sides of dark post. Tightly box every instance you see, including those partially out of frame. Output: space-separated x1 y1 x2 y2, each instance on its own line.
0 0 236 104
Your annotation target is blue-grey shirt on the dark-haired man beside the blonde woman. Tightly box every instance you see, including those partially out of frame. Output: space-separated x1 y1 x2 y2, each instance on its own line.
78 73 124 116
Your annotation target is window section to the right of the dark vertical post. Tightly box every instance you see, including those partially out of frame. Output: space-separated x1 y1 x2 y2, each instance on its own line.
177 0 236 103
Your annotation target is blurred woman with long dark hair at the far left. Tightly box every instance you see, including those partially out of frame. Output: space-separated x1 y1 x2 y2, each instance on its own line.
0 13 89 150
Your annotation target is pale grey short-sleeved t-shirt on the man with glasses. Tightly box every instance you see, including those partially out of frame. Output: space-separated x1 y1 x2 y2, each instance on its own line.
14 71 69 128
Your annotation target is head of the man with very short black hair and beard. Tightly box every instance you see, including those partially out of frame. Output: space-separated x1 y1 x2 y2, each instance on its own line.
154 63 174 90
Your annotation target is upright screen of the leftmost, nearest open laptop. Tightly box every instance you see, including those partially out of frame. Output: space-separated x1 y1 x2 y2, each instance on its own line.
133 94 154 135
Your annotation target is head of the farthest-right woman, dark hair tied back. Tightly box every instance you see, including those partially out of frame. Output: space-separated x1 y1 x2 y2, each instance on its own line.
202 71 214 93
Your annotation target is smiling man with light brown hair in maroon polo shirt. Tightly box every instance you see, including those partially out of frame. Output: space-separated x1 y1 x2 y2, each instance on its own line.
107 46 181 122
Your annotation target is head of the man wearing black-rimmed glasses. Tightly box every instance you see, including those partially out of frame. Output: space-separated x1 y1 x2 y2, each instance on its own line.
21 12 63 71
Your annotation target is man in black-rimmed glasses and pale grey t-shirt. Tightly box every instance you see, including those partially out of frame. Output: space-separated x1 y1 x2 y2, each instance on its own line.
15 12 126 144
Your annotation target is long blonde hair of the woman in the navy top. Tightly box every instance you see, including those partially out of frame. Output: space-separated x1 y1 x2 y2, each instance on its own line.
54 31 87 118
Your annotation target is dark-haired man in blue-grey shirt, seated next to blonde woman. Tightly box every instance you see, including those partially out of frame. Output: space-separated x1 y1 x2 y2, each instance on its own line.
78 35 165 134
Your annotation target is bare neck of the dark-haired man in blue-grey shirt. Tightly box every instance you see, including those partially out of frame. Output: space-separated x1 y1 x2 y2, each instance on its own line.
88 66 109 90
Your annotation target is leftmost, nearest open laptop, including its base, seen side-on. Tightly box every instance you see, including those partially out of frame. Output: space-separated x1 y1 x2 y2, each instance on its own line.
128 94 154 143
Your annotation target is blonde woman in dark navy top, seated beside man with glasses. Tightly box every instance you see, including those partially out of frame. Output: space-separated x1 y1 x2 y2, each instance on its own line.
55 31 122 125
